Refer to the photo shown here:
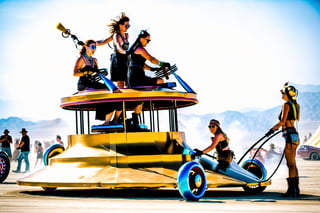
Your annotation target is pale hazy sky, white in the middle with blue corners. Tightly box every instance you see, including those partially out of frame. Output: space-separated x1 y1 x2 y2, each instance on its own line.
0 0 320 121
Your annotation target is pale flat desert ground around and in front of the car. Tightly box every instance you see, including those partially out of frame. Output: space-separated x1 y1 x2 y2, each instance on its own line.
0 156 320 213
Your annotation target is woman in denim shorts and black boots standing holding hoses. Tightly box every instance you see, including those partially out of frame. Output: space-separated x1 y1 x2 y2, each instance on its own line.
266 82 300 197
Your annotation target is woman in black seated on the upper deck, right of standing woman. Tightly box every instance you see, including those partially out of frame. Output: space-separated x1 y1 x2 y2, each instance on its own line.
128 30 170 126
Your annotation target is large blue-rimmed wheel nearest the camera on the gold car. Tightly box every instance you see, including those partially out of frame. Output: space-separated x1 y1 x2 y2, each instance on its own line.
177 161 207 201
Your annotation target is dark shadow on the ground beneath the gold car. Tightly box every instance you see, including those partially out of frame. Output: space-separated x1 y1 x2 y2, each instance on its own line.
20 189 320 203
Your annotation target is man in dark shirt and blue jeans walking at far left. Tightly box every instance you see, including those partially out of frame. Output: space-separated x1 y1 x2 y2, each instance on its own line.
13 128 30 173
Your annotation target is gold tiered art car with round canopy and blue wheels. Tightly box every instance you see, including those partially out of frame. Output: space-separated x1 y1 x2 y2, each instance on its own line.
17 69 271 200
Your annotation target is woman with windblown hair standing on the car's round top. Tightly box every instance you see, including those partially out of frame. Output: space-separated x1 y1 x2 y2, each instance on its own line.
97 12 130 88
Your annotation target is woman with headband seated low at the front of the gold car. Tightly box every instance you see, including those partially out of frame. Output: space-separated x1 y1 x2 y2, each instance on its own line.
195 119 234 171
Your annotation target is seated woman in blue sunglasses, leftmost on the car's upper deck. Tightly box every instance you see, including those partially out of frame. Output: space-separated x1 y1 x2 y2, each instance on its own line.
73 40 121 125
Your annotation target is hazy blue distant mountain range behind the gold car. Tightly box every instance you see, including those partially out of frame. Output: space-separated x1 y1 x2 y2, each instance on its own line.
0 90 320 143
